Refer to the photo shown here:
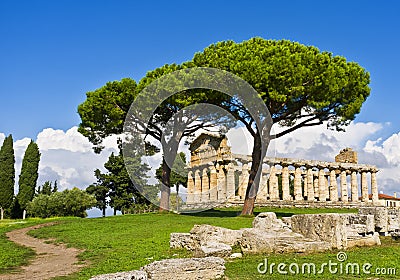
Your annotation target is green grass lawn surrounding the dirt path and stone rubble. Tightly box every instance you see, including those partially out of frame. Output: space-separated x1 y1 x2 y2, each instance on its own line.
0 208 400 279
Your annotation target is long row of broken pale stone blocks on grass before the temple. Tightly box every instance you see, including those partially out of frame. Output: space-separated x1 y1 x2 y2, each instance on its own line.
170 206 400 257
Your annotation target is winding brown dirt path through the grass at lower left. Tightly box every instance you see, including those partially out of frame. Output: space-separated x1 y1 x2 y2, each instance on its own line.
0 223 83 280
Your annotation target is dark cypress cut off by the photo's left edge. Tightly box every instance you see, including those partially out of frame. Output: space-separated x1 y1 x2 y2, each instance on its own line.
0 134 15 213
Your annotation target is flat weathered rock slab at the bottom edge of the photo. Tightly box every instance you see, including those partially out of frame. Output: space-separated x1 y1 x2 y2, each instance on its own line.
142 257 225 280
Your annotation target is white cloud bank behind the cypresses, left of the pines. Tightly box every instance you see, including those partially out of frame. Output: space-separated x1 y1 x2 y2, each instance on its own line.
6 127 118 192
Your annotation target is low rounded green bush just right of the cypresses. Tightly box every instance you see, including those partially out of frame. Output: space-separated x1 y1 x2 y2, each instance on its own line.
27 188 96 218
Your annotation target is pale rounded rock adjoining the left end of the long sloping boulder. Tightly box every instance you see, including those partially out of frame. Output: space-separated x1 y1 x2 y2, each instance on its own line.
190 225 243 246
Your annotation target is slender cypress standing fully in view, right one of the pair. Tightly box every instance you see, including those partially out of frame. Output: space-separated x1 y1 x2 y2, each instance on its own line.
17 140 40 210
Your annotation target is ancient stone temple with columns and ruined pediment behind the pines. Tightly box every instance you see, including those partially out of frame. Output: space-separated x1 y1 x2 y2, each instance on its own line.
186 134 378 207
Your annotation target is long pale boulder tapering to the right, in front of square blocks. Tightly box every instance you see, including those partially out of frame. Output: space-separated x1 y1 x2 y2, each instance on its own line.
239 229 331 254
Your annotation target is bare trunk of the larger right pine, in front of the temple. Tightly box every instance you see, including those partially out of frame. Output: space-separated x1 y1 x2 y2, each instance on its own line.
241 132 266 215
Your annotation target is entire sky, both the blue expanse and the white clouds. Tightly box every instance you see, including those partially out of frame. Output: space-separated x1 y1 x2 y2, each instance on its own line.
0 0 400 201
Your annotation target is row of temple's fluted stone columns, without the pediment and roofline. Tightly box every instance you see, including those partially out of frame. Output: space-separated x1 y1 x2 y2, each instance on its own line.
187 163 378 204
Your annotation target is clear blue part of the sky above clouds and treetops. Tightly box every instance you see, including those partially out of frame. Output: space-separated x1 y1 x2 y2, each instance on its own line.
0 0 400 139
